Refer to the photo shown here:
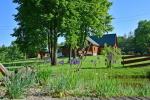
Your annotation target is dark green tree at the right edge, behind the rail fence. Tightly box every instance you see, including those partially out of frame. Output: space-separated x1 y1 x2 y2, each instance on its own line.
135 20 150 54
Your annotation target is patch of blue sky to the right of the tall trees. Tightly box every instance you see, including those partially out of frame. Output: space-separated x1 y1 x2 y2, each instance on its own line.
110 0 150 35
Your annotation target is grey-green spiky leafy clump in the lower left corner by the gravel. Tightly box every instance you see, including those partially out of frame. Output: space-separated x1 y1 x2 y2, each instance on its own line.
4 72 35 99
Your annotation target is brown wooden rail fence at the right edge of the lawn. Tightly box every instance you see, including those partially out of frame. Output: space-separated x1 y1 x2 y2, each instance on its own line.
121 55 150 67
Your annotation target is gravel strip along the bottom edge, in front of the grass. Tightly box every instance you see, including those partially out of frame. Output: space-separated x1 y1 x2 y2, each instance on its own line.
0 87 150 100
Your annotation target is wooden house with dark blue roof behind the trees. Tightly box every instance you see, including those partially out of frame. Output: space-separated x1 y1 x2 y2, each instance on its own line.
87 34 118 56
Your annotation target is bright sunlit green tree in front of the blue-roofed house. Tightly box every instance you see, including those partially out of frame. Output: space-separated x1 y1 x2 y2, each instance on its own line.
63 0 112 59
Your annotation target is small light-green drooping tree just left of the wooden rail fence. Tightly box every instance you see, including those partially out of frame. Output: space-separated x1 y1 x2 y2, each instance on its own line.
102 45 121 68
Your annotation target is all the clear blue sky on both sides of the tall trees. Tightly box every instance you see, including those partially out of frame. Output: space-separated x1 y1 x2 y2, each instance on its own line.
0 0 150 46
